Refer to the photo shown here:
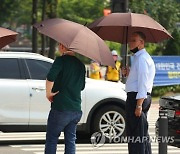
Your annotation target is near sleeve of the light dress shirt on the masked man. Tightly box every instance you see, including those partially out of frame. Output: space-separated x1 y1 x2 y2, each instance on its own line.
136 56 149 99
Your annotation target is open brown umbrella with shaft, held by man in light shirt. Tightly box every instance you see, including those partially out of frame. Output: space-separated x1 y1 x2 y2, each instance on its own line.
88 13 172 65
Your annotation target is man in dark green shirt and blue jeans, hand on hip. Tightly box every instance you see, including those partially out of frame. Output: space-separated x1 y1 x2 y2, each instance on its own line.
45 44 85 154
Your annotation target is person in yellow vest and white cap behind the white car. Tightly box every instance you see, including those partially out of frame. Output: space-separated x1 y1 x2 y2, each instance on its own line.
105 50 121 82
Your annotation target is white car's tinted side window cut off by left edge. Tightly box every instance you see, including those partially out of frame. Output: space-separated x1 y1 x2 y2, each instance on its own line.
0 58 21 79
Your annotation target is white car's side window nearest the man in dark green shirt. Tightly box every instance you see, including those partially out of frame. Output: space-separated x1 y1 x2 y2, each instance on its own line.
26 59 52 80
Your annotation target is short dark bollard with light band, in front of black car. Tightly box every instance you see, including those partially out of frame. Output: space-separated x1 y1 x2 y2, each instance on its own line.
158 110 168 154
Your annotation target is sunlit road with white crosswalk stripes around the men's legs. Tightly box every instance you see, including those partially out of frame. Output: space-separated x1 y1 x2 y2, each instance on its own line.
0 102 180 154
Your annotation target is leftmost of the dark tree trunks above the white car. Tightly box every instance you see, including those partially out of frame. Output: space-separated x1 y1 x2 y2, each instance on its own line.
32 0 38 53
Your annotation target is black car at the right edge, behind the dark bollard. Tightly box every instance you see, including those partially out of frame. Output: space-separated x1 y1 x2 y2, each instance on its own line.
156 95 180 147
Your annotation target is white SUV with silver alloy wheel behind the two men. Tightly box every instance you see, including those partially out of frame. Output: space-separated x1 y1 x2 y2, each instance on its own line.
0 52 126 138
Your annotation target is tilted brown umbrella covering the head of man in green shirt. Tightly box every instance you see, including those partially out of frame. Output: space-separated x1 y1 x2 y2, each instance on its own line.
34 18 115 66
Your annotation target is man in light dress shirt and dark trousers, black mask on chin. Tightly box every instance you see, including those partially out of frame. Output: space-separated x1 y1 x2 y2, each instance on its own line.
123 32 155 154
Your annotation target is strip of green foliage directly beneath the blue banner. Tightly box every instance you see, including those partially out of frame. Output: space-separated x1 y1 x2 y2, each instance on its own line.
152 85 180 97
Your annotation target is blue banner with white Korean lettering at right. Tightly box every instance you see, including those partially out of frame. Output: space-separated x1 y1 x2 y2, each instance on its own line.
152 56 180 86
